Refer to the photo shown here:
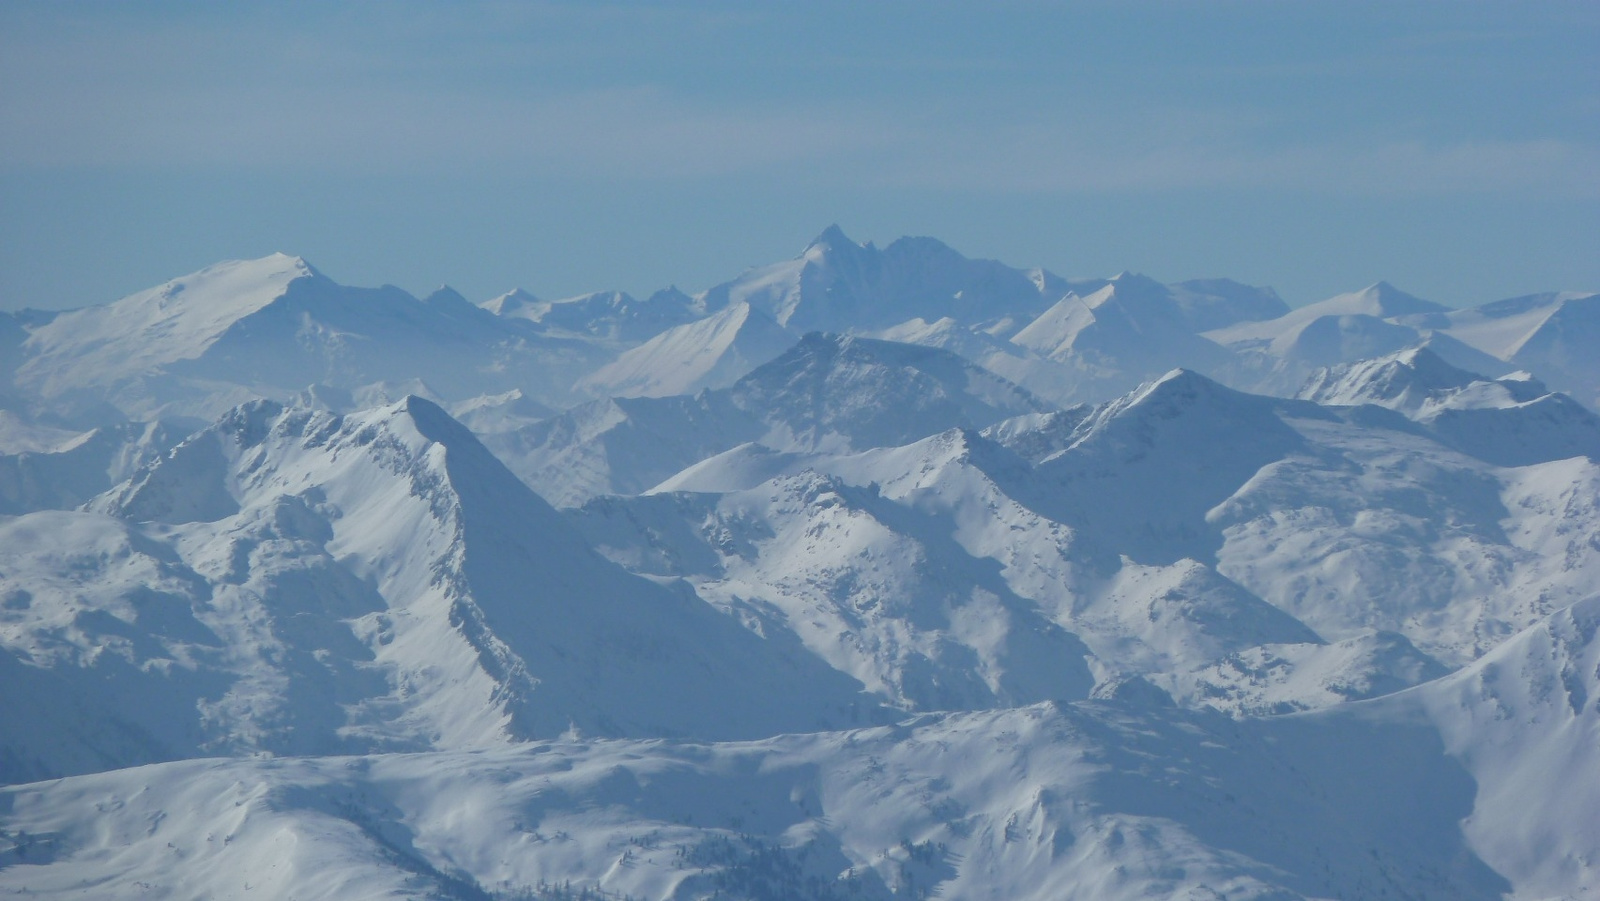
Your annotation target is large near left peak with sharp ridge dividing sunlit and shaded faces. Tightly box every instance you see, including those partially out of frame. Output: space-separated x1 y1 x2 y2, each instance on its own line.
0 398 870 778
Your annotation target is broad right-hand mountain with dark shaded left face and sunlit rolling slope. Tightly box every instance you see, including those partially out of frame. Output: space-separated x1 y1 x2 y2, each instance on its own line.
972 374 1600 664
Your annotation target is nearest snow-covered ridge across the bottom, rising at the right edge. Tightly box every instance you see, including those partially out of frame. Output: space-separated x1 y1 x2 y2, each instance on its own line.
0 602 1600 899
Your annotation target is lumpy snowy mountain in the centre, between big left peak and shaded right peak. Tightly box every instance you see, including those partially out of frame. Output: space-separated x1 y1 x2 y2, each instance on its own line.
582 430 1320 720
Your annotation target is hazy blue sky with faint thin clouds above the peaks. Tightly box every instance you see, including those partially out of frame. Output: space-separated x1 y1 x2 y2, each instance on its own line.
0 0 1600 307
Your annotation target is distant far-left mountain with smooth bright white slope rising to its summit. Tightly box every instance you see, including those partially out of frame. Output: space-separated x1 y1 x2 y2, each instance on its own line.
16 254 603 424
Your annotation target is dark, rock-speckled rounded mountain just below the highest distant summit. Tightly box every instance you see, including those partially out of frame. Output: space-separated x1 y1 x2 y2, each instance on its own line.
485 334 1043 507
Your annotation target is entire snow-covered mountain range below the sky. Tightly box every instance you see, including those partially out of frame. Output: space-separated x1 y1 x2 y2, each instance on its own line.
0 227 1600 901
